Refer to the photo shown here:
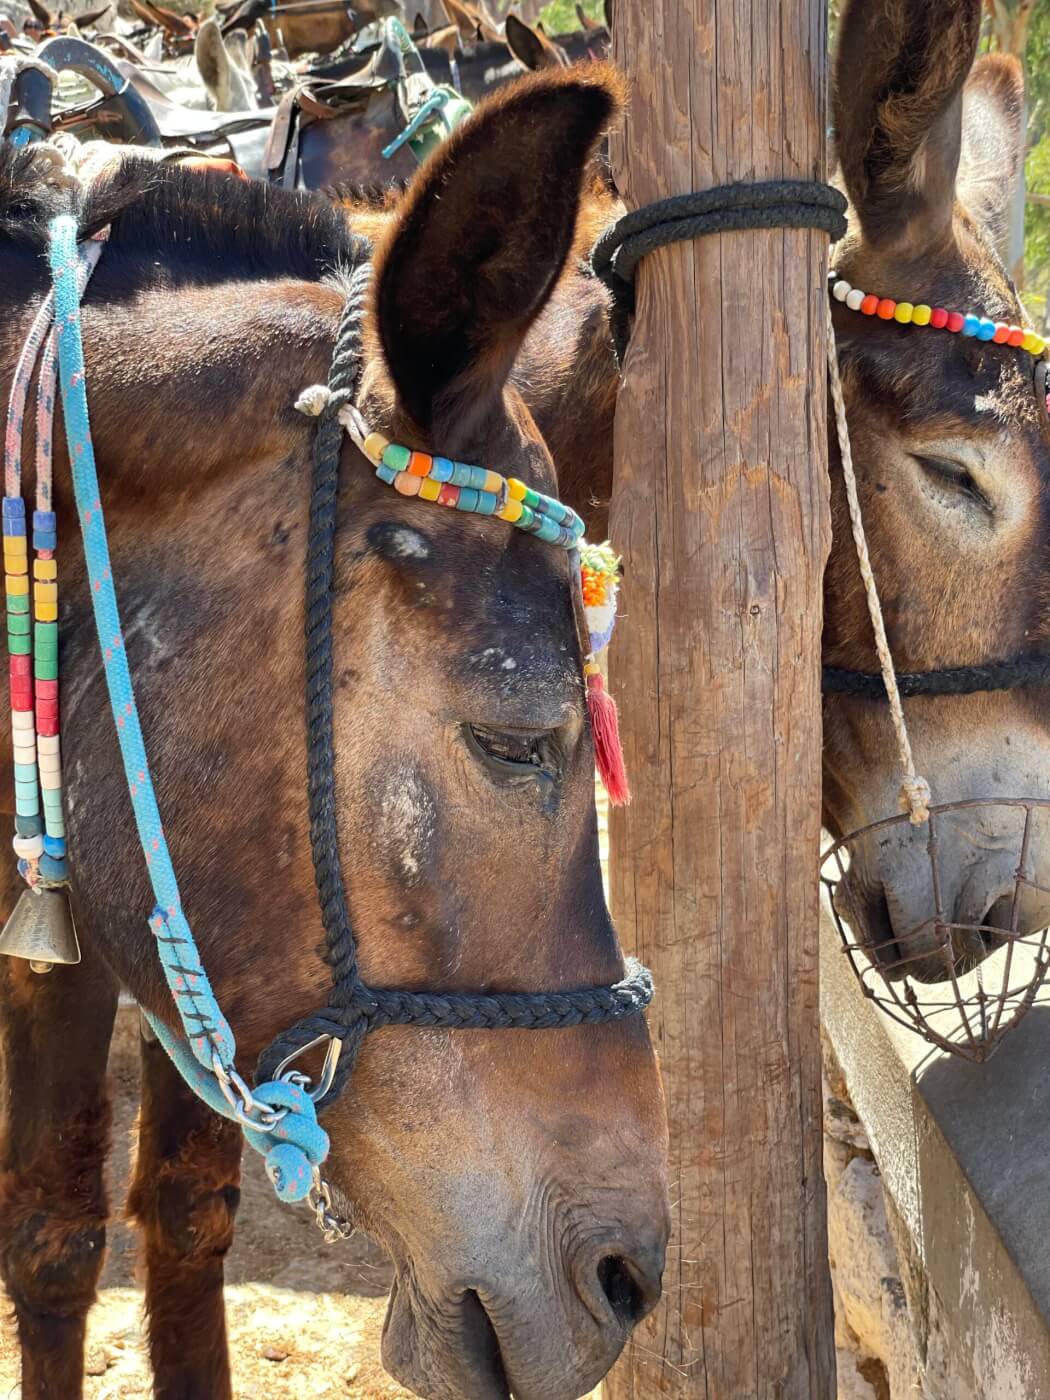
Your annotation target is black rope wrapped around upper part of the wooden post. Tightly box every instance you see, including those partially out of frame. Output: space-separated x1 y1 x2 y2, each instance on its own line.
591 179 846 363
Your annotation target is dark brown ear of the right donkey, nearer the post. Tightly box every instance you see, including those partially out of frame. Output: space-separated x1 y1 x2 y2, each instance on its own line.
834 0 981 256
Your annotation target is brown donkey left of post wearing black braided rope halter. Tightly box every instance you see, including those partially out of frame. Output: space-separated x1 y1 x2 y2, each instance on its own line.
0 67 666 1400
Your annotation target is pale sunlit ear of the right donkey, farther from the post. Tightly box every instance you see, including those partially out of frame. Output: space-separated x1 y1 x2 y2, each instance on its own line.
958 53 1025 241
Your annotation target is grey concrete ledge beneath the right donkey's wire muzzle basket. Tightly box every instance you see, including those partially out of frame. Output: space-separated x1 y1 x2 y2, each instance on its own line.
820 913 1050 1400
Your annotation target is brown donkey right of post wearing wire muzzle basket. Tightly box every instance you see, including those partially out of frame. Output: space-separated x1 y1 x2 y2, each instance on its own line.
825 0 1050 980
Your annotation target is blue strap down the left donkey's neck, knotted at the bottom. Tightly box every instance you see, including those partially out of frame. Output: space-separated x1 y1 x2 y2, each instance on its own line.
49 214 329 1200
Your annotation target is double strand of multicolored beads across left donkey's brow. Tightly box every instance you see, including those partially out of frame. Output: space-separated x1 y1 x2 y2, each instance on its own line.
354 433 584 549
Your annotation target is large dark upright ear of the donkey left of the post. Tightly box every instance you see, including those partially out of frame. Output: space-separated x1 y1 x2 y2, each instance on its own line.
375 63 623 431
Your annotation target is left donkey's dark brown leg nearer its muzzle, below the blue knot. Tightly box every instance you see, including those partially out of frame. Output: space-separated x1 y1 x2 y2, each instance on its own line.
127 1039 241 1400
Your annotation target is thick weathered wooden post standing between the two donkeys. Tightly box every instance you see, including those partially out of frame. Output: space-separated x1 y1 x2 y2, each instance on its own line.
608 0 834 1400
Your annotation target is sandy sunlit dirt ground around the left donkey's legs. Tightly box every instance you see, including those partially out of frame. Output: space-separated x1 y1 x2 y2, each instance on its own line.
0 1008 409 1400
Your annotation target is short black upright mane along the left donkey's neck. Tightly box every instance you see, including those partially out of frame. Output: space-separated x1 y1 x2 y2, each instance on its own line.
0 147 361 284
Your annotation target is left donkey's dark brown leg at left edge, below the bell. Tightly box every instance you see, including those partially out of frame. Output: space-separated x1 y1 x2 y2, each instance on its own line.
0 958 118 1400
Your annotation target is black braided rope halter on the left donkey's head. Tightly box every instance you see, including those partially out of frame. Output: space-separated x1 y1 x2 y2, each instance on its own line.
256 255 652 1109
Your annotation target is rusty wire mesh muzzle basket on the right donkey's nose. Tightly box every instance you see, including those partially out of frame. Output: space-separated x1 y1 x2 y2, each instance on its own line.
820 798 1050 1064
